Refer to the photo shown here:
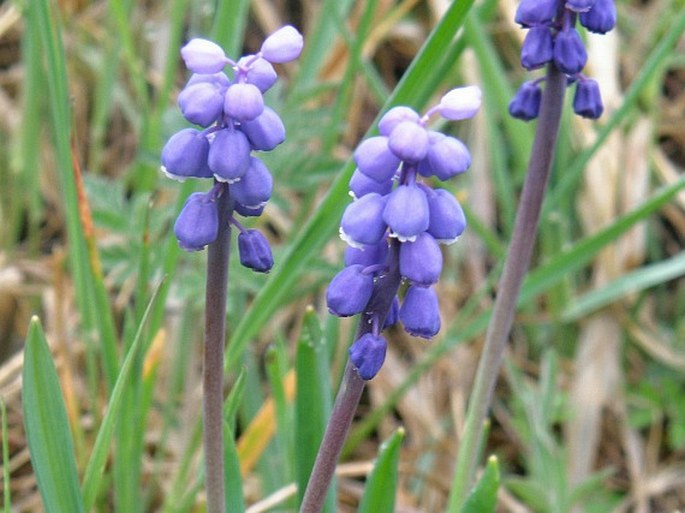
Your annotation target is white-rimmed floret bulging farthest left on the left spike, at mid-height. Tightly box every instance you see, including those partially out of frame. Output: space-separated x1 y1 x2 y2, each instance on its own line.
161 128 212 182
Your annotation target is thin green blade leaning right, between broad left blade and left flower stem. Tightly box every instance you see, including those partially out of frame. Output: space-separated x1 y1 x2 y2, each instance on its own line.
80 283 161 511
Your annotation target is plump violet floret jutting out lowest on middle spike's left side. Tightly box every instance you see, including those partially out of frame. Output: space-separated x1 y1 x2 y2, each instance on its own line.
326 264 373 317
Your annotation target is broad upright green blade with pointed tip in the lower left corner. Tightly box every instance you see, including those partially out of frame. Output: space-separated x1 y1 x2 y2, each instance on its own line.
22 317 85 513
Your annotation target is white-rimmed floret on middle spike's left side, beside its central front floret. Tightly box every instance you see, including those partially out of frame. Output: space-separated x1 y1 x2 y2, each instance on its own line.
340 193 387 247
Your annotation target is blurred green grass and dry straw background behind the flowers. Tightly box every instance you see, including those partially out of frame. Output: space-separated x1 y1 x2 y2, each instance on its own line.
0 0 685 513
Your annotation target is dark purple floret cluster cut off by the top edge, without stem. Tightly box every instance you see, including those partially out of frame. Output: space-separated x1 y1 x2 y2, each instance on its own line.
509 0 616 121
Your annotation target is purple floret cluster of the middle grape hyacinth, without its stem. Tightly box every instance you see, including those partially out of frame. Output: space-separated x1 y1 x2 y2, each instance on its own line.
326 86 481 380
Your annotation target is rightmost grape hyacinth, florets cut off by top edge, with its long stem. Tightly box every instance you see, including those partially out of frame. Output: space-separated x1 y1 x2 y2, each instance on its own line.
447 0 616 511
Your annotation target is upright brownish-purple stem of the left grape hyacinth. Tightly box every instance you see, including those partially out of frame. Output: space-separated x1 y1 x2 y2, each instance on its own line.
202 183 233 513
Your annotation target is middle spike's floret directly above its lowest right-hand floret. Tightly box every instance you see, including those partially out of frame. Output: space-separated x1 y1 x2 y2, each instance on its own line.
400 233 442 287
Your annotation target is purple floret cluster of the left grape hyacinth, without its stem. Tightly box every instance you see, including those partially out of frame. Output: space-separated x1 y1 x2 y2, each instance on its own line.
161 25 303 272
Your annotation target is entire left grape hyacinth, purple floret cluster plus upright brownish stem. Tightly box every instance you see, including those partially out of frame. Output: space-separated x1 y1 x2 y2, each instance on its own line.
161 26 303 513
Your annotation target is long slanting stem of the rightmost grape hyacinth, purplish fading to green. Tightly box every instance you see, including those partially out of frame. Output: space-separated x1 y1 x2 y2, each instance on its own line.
448 64 566 513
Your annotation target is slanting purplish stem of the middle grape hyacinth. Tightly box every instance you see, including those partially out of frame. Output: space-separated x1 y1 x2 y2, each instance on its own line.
300 239 402 513
